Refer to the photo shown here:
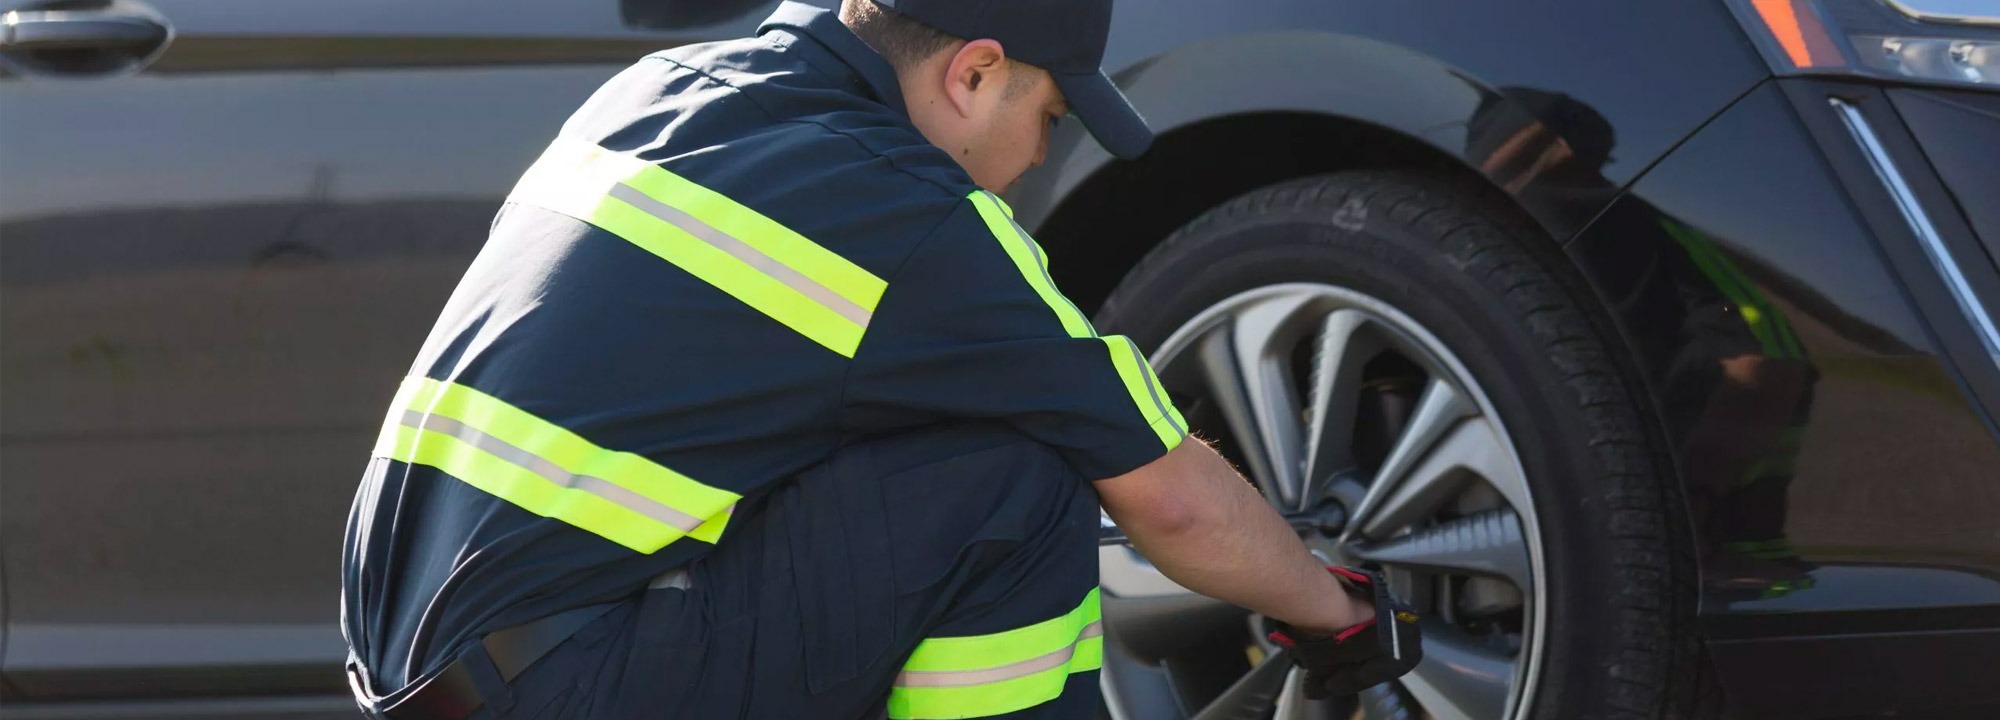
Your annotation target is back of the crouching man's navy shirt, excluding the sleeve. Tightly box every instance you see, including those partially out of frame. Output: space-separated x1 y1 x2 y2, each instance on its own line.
348 21 972 686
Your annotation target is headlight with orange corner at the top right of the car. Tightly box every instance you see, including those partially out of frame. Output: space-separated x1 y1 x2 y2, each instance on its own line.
1728 0 2000 88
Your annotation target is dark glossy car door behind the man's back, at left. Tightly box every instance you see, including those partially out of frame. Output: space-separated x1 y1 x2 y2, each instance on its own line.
0 0 796 716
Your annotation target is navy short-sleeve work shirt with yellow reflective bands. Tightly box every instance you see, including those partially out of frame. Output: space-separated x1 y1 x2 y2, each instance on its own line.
344 4 1186 690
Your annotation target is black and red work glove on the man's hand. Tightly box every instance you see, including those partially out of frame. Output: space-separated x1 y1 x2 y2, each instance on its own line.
1270 566 1424 700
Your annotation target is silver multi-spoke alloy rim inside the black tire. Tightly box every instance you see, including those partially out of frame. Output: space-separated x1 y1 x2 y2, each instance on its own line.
1100 284 1548 720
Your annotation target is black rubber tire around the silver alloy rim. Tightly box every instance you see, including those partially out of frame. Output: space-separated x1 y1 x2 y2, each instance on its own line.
1098 172 1716 720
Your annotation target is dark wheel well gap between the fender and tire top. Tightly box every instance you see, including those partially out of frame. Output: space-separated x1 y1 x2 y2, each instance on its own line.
1034 112 1532 314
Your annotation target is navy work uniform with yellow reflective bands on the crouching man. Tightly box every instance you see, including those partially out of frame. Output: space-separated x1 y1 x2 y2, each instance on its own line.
342 4 1186 718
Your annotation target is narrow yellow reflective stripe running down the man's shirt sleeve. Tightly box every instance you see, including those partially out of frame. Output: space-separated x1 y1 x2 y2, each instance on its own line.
970 190 1188 450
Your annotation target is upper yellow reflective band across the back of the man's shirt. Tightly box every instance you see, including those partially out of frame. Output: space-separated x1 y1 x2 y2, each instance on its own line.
508 138 888 358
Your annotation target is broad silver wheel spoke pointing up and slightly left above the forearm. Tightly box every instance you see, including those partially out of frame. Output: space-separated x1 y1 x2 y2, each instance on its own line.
1198 294 1312 506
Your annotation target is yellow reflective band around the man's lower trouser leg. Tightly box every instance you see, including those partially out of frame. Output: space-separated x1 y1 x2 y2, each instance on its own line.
888 588 1104 720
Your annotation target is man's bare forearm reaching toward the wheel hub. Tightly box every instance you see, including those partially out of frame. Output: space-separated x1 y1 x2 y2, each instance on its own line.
1098 438 1368 630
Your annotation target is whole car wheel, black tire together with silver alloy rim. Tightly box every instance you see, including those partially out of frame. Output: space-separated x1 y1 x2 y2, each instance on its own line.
1098 172 1700 720
